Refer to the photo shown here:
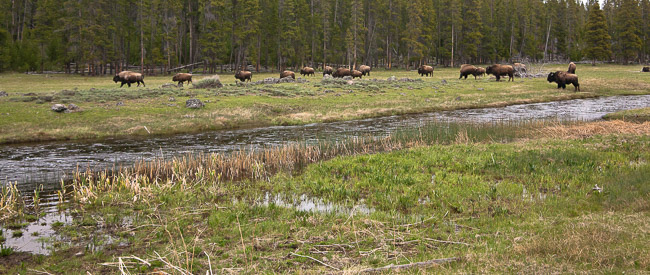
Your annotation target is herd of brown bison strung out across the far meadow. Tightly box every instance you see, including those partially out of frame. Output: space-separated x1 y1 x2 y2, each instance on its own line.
113 62 650 91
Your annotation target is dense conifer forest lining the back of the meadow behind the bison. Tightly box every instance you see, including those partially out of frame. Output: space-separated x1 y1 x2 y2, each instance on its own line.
0 0 650 75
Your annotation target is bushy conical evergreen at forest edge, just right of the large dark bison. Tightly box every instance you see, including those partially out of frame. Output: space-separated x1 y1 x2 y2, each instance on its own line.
585 2 612 65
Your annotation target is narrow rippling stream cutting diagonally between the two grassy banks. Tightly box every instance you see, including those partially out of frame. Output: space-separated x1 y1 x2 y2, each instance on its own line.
0 95 650 193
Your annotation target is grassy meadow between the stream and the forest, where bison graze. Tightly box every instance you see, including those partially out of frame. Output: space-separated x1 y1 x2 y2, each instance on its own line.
0 65 650 143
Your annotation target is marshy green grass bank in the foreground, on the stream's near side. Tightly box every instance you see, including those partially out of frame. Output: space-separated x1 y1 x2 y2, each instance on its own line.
0 121 650 274
